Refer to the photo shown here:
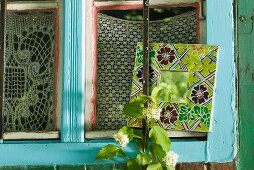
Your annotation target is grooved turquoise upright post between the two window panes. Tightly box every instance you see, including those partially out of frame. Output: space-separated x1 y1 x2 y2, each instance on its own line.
61 0 85 142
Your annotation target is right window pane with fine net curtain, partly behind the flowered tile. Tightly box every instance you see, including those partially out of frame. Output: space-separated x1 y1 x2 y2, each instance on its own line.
96 8 198 130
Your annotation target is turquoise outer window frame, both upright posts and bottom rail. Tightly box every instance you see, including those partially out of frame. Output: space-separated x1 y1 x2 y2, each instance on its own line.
0 0 236 165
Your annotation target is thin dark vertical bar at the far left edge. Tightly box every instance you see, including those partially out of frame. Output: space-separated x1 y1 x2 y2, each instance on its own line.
0 0 6 141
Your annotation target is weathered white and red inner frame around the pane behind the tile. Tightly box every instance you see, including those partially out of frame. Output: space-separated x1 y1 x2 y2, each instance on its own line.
85 0 206 139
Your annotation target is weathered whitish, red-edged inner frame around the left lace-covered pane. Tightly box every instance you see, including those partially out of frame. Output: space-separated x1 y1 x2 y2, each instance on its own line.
3 0 62 140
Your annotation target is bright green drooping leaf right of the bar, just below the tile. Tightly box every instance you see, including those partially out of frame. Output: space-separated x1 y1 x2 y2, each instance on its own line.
149 126 171 152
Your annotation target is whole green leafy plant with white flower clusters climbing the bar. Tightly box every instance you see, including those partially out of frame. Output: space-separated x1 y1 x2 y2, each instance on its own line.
96 84 180 170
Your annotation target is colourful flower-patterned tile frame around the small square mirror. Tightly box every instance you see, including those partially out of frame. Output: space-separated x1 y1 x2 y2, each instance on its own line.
129 43 218 132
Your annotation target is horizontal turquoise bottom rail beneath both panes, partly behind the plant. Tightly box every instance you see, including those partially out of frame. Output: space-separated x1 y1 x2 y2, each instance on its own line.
0 140 206 165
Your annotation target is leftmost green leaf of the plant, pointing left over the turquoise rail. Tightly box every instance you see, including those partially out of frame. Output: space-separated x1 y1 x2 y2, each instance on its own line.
96 144 126 160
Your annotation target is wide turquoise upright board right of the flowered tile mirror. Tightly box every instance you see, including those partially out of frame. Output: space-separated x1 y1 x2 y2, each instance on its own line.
206 0 237 162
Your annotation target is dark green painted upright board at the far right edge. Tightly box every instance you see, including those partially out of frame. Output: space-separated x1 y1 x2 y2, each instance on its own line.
237 0 254 170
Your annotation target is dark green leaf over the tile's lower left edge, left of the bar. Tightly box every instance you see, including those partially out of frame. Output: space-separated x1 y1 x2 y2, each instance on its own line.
123 102 144 119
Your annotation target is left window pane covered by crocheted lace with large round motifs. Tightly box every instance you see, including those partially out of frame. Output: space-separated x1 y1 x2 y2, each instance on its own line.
4 11 57 132
